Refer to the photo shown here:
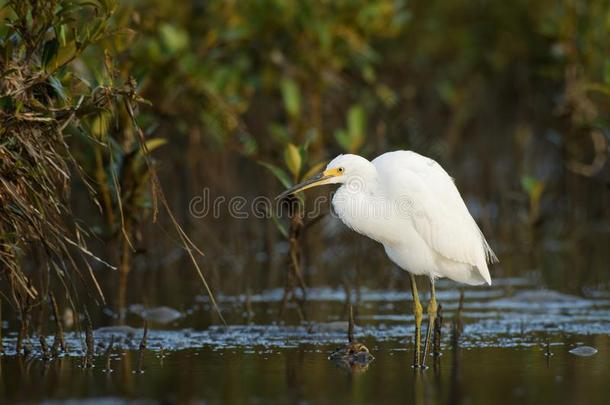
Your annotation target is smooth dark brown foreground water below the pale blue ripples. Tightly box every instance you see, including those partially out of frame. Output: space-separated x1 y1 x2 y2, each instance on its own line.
2 336 610 404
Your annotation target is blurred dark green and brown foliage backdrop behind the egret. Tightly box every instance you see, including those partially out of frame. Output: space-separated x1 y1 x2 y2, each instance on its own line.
0 0 610 322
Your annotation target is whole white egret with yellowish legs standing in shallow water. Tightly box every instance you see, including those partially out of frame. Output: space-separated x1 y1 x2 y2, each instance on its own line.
278 151 498 367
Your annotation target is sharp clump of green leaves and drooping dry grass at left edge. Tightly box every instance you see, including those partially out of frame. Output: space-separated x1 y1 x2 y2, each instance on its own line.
0 0 129 306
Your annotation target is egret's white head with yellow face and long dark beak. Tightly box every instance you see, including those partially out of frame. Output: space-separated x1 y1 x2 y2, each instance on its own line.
278 155 375 198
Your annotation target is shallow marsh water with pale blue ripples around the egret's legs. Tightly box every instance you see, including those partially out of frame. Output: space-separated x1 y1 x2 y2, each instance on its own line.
0 277 610 404
